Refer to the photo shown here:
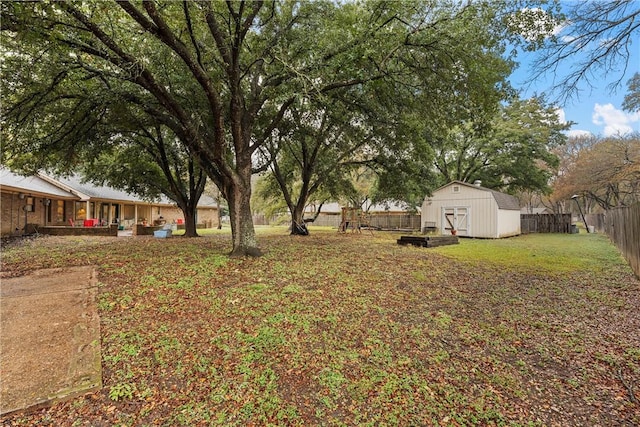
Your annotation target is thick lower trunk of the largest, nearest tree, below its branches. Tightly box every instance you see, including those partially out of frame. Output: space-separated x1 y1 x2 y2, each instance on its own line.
227 173 262 257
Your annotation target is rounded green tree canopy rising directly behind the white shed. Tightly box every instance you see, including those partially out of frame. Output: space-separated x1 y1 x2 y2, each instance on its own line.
434 98 570 193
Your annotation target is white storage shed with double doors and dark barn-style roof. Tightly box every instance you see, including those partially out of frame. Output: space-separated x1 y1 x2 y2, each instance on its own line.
422 181 520 239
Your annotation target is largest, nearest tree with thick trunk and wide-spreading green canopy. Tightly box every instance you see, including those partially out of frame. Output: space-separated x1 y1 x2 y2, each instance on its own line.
0 0 560 249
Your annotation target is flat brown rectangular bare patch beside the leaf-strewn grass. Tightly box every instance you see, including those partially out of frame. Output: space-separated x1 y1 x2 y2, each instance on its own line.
0 266 102 414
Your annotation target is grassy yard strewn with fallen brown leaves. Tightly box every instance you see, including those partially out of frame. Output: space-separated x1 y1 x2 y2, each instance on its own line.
2 232 640 426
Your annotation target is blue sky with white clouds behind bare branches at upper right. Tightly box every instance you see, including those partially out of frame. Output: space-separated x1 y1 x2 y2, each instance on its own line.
510 5 640 136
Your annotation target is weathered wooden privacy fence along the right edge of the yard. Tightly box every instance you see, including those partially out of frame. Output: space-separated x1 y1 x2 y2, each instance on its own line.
604 203 640 278
